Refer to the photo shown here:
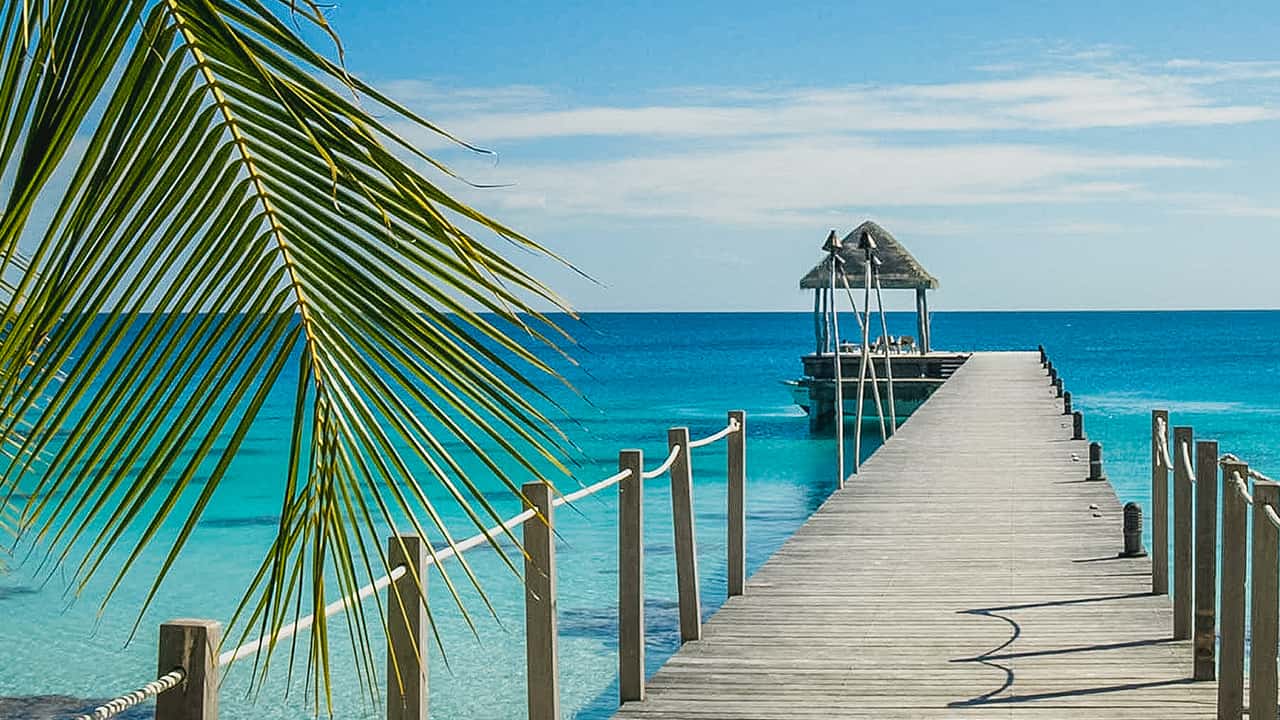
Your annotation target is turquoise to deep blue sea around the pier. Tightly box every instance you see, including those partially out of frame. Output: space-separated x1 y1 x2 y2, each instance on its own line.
0 311 1280 720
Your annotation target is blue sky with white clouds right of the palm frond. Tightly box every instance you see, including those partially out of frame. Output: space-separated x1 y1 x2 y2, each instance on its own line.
314 0 1280 310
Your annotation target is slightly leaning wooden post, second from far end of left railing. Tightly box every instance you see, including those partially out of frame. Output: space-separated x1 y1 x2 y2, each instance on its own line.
667 428 703 643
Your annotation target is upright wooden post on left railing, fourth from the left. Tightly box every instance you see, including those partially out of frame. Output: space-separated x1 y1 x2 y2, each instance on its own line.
618 450 644 702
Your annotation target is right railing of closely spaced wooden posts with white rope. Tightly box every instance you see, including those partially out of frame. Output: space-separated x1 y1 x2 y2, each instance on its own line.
1151 410 1280 720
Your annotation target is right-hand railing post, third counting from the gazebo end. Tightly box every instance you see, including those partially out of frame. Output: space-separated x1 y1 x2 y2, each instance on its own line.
1192 439 1217 680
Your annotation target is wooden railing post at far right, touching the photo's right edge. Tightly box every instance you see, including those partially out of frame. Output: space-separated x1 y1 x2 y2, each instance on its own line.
1249 480 1280 720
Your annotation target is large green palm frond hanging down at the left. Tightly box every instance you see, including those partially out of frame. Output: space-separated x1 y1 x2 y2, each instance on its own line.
0 0 567 689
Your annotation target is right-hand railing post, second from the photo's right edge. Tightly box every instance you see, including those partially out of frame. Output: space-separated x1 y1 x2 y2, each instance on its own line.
1217 462 1249 720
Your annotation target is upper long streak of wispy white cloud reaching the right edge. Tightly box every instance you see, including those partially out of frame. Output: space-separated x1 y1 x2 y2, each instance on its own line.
392 59 1280 150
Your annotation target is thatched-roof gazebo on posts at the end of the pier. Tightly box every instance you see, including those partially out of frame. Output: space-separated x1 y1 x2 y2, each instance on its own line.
800 220 938 354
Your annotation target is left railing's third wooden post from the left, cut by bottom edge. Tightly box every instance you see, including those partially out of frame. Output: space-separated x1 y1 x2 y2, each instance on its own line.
521 483 559 720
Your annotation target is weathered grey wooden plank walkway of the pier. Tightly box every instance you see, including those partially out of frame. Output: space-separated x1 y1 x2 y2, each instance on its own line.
617 352 1216 720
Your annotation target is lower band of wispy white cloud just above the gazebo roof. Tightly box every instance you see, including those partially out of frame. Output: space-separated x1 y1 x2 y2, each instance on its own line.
458 136 1212 223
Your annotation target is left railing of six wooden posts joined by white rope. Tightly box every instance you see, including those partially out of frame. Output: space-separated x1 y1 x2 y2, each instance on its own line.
76 410 746 720
